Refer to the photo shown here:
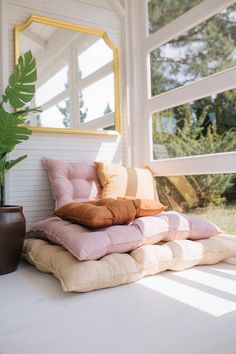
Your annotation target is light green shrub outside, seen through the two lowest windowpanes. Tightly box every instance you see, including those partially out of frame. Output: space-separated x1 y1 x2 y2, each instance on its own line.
153 99 236 210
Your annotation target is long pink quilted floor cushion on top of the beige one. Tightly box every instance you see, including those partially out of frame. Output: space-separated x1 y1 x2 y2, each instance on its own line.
27 211 220 261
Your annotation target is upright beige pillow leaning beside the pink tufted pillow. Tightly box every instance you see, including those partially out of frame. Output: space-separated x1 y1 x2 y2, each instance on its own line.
95 162 158 200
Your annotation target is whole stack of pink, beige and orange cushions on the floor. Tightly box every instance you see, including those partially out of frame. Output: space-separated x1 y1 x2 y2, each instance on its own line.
23 159 236 292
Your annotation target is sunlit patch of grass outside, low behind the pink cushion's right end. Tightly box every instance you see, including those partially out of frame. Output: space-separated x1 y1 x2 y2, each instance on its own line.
191 204 236 235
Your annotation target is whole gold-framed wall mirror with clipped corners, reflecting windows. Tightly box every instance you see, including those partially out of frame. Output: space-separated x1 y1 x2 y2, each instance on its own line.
14 15 120 135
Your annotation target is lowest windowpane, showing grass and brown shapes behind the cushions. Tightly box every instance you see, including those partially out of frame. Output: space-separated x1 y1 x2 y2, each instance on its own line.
156 174 236 234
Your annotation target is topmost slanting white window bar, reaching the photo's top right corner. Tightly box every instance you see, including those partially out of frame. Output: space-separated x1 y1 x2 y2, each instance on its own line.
145 0 235 53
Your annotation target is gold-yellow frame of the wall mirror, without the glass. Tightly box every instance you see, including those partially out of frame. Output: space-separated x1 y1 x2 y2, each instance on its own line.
14 15 121 135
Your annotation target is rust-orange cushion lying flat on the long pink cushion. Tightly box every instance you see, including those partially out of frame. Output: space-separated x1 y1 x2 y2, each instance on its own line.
54 198 165 229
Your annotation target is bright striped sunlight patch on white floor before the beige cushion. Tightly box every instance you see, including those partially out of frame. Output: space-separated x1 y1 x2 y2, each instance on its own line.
138 268 236 317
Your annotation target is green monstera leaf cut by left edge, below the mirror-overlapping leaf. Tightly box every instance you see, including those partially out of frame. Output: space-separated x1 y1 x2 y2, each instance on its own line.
0 109 31 154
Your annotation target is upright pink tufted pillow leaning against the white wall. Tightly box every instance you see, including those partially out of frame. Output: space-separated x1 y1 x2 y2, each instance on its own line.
43 158 101 208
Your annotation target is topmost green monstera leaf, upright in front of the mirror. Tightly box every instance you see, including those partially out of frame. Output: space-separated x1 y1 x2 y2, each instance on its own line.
2 50 37 108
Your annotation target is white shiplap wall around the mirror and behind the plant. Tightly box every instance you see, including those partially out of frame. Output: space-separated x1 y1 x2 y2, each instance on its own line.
0 0 126 228
